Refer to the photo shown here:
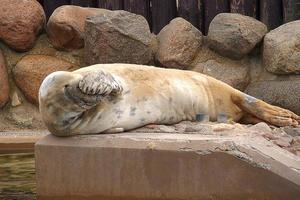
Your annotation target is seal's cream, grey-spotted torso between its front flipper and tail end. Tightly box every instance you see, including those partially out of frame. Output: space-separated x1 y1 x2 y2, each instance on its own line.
74 66 243 132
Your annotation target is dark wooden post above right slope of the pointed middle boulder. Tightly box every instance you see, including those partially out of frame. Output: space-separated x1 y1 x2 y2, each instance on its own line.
178 0 204 31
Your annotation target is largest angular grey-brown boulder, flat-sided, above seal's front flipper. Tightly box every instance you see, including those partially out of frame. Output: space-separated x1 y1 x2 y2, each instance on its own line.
85 11 154 64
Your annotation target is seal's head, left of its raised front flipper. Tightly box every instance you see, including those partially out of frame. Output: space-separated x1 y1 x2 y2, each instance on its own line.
39 71 82 134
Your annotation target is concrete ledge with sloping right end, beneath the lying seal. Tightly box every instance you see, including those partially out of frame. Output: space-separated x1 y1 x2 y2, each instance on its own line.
35 133 300 200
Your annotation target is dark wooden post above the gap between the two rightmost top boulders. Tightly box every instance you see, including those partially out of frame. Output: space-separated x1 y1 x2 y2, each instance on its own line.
260 0 283 30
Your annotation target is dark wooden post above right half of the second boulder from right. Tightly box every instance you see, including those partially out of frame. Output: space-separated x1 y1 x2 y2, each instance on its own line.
230 0 259 18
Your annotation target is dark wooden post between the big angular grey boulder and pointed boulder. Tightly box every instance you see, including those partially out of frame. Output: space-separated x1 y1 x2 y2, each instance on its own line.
151 0 177 34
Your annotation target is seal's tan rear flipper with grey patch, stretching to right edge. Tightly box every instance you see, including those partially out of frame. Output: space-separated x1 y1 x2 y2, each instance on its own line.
231 92 300 126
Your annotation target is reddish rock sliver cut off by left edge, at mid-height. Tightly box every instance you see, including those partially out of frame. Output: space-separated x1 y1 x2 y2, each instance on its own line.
0 50 9 108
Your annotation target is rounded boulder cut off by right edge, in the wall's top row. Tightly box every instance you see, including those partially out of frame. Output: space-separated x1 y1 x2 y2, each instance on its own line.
263 20 300 74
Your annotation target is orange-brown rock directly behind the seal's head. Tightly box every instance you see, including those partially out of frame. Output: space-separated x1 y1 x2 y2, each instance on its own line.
13 55 75 105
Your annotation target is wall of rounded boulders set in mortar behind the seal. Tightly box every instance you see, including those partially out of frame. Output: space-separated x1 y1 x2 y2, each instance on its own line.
0 0 300 130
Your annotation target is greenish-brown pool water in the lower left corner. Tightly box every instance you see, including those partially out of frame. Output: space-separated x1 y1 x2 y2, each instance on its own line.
0 154 36 200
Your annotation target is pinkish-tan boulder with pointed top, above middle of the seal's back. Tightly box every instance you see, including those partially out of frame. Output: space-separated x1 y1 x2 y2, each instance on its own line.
156 17 202 69
